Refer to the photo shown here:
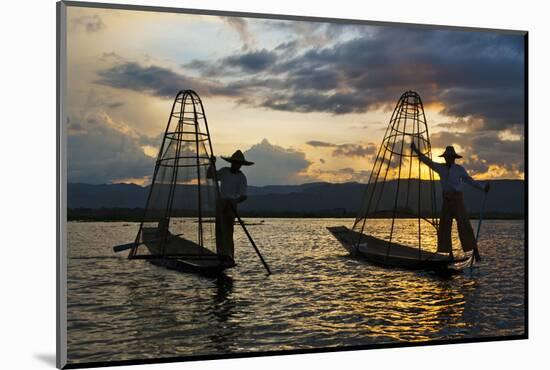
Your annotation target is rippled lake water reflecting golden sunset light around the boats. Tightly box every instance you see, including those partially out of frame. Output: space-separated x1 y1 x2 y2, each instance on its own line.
68 219 525 363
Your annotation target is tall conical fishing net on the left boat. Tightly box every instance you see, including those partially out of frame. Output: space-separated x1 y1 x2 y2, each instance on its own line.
129 90 218 259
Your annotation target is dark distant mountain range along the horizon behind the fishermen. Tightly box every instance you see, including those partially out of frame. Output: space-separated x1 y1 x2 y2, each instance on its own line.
67 180 524 219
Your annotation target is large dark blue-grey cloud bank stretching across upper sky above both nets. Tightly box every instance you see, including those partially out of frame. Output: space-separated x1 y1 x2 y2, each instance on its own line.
99 26 524 134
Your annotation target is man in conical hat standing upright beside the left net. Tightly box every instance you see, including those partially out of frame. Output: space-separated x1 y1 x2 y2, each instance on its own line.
206 150 254 266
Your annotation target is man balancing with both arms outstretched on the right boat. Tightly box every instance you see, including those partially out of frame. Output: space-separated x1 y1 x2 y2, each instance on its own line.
411 142 490 260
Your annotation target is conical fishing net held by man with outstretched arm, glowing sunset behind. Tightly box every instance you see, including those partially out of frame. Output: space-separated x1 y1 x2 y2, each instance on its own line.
353 91 438 259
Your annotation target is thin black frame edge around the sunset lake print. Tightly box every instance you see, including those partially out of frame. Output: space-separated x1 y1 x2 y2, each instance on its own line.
56 1 529 369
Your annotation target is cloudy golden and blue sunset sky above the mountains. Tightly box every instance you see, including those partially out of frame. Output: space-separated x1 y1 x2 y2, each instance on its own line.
67 7 524 185
